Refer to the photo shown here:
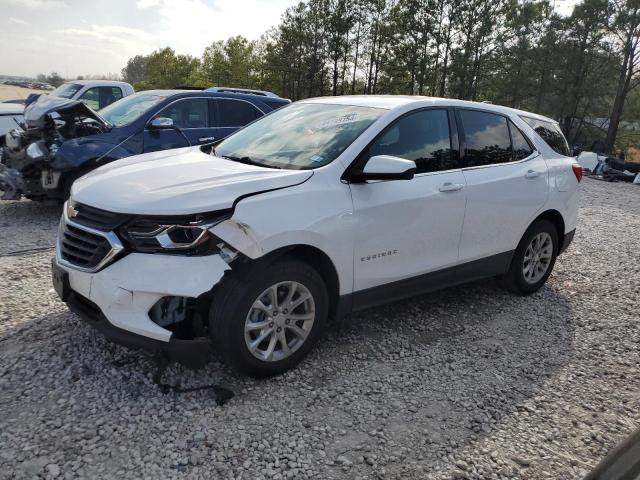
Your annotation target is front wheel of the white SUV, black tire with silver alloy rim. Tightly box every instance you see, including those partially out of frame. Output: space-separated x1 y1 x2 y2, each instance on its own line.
209 258 328 377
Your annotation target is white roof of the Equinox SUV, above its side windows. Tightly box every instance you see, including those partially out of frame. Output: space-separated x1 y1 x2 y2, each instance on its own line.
301 95 555 123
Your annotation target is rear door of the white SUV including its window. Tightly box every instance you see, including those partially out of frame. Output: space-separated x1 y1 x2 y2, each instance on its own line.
456 109 549 264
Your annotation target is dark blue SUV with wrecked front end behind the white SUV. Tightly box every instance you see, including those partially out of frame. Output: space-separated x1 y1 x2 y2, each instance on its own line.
0 87 290 201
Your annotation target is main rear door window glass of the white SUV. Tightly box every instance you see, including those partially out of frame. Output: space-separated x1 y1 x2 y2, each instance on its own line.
459 110 512 167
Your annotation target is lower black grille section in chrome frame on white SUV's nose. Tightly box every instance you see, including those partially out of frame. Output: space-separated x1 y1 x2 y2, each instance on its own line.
60 223 112 269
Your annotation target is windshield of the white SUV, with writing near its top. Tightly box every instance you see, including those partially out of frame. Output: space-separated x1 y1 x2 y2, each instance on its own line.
215 103 386 170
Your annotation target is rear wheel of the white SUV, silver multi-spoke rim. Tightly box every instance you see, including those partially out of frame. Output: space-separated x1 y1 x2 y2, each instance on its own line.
499 219 559 295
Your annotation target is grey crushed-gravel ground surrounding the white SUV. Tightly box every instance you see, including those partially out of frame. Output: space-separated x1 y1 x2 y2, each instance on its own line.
0 179 640 480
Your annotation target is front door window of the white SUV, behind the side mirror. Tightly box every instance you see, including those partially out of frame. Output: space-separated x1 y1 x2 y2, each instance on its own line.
368 110 459 173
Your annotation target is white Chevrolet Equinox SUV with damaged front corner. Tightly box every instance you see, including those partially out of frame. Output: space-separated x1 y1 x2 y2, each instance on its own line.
53 96 582 376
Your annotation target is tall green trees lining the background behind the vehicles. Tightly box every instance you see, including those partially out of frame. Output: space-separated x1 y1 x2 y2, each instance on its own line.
123 0 640 150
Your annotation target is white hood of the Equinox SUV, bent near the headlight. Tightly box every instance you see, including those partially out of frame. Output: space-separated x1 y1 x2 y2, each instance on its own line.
71 147 313 215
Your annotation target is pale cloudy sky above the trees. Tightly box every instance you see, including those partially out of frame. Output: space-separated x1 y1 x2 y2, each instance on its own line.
0 0 576 78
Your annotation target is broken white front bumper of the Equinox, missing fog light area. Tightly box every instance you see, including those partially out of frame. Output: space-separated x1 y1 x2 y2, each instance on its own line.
53 250 229 368
